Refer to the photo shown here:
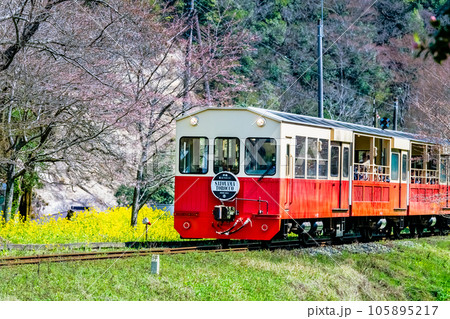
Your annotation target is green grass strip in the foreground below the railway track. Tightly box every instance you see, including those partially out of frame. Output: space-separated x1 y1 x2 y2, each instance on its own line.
0 237 450 300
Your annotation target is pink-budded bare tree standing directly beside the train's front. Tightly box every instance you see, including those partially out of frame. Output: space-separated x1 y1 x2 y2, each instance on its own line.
100 5 252 226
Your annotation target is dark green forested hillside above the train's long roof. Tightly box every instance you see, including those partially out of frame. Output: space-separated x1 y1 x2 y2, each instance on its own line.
214 0 449 128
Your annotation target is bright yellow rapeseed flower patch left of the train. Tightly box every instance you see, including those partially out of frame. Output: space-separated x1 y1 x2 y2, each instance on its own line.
0 206 180 244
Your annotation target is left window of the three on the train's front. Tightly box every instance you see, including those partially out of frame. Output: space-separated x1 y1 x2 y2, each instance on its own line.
179 137 208 174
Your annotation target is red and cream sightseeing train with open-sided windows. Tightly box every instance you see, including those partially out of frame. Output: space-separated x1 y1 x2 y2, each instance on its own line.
174 108 450 240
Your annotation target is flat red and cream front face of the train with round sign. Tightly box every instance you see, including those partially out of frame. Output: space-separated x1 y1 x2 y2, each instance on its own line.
174 108 281 240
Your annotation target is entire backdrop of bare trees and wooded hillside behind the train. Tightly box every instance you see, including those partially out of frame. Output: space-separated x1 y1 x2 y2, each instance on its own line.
0 0 450 222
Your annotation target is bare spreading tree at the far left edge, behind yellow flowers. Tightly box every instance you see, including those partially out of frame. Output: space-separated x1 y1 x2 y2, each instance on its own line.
0 0 127 221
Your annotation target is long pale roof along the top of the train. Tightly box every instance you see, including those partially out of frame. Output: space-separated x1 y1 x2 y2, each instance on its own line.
178 107 442 144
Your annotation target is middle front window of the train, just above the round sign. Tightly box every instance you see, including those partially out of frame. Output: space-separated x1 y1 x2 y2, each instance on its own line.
214 137 239 174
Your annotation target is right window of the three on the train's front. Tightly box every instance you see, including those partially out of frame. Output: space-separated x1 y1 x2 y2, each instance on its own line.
245 138 277 175
